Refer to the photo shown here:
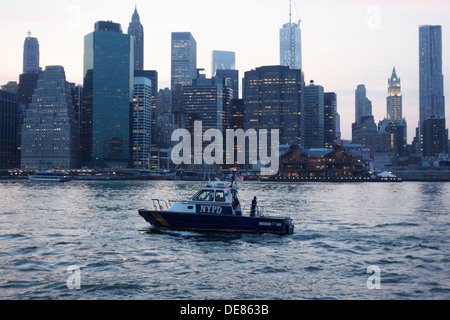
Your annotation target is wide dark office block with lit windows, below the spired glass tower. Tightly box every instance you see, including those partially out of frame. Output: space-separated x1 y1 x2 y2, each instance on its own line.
243 66 305 145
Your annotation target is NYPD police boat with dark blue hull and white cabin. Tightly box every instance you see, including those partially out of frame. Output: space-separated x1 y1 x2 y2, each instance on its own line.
139 179 294 235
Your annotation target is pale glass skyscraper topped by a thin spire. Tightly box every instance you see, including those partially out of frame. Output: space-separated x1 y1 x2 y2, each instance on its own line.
280 1 302 69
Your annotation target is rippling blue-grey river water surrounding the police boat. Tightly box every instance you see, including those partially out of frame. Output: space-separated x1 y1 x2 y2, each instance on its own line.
0 181 450 300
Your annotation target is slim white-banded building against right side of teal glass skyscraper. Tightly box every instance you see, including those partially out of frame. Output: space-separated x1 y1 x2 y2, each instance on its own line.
131 77 152 169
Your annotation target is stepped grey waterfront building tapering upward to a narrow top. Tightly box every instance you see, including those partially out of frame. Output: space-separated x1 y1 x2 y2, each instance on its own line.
21 66 78 170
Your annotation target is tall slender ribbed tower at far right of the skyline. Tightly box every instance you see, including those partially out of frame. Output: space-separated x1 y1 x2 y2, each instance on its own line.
419 26 445 124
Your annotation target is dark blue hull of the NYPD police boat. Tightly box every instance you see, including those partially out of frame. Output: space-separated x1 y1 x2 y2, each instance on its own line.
139 210 294 235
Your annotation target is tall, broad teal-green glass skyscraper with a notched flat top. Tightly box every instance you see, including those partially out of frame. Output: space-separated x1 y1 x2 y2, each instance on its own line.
81 21 134 168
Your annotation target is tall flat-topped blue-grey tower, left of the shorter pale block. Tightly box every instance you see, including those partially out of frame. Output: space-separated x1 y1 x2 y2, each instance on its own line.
171 32 197 90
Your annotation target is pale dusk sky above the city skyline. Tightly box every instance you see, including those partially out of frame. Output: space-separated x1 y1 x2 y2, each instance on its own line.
0 0 450 143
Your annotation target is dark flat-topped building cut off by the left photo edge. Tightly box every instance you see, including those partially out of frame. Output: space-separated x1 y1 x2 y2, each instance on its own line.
0 89 19 169
